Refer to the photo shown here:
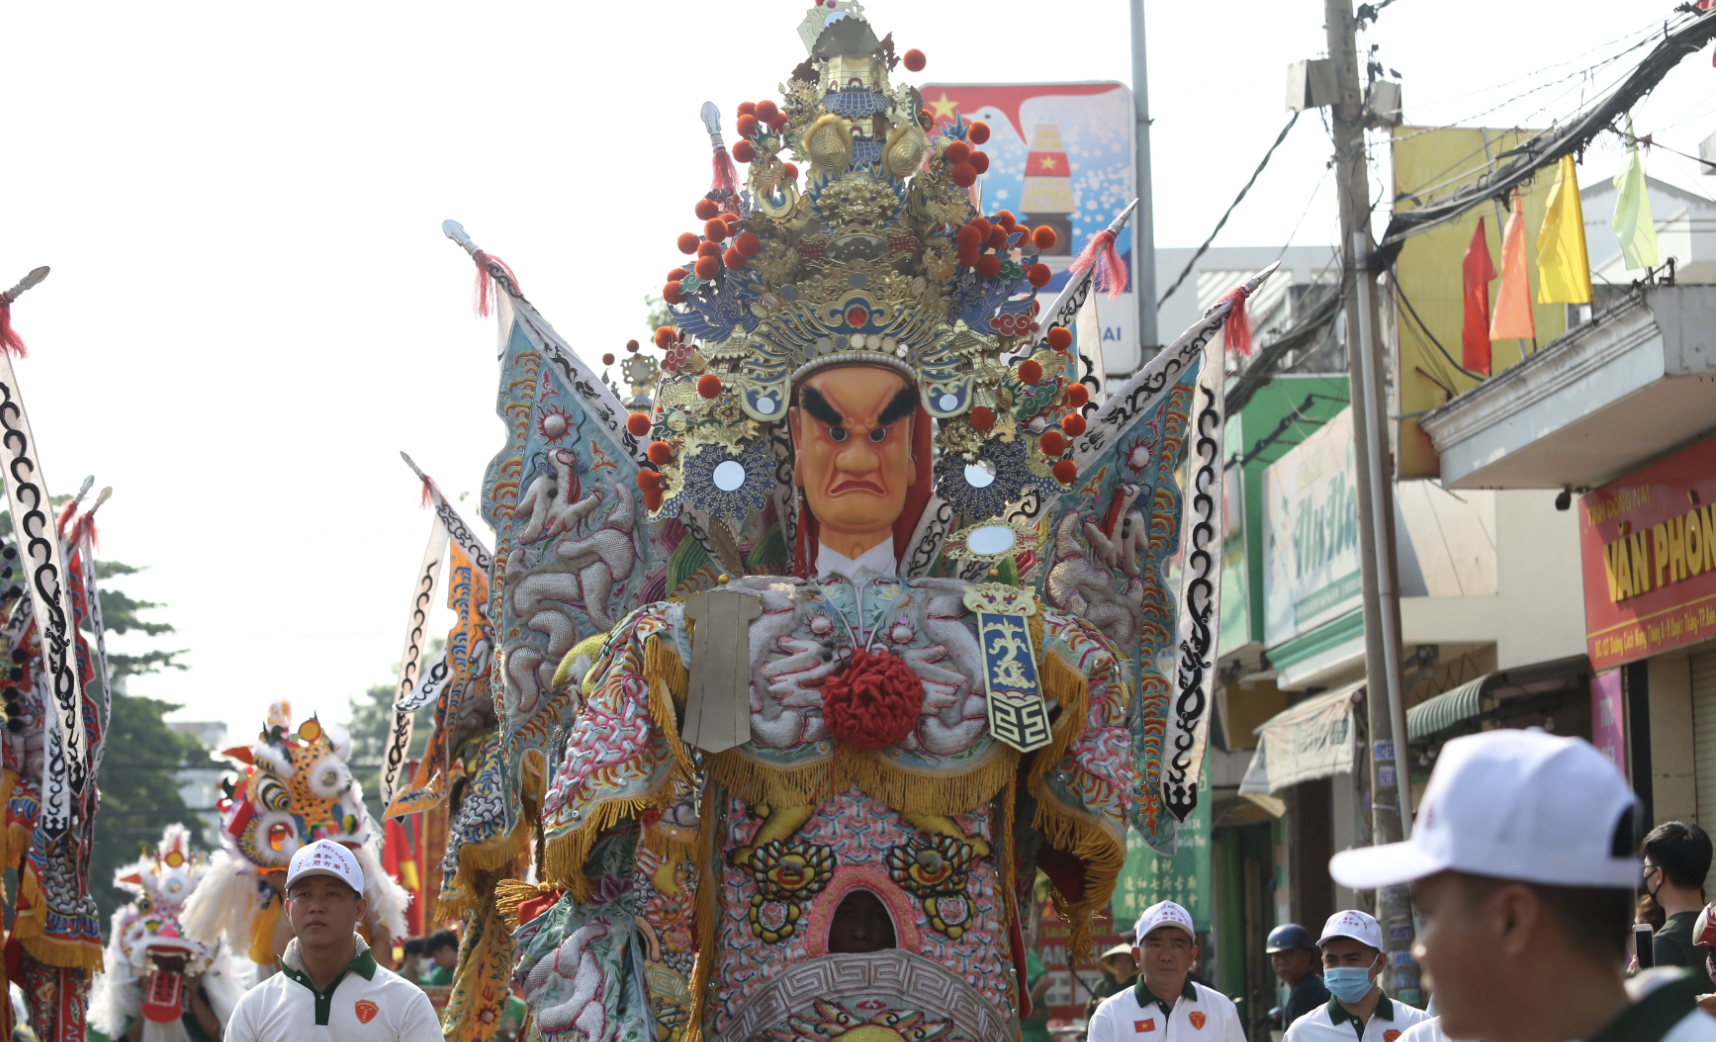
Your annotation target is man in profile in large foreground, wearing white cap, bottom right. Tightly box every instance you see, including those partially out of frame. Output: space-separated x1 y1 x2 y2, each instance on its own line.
1328 730 1716 1042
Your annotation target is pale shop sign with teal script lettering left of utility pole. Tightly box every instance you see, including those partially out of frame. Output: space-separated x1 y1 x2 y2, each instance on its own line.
1263 409 1363 647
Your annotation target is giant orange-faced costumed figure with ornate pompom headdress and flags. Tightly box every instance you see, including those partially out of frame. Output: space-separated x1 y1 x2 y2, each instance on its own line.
446 0 1260 1042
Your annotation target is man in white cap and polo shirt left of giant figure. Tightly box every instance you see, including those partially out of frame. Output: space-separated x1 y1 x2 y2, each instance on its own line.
225 839 441 1042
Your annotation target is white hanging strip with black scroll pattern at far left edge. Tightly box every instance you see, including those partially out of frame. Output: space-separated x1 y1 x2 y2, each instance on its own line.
0 350 89 838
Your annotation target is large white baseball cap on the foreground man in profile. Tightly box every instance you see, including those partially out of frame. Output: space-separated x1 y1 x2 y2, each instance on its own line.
1328 730 1639 889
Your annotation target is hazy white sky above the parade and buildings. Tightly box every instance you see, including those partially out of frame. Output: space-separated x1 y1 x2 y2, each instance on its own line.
0 0 1716 748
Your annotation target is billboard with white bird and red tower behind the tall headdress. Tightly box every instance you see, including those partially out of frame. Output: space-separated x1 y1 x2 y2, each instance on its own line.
921 82 1153 374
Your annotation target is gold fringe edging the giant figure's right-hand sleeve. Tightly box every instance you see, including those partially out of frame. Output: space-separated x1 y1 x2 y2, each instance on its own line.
1024 654 1126 961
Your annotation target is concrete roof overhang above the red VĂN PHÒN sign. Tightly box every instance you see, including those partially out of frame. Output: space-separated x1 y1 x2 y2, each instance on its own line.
1421 285 1716 489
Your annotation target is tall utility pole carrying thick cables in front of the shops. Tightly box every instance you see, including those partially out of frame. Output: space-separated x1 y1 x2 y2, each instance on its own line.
1323 0 1423 1003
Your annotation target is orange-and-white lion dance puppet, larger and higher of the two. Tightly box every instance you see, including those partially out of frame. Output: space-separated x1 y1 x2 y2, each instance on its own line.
184 702 410 975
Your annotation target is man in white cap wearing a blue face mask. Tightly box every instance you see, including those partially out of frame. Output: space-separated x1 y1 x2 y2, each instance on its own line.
1282 910 1429 1042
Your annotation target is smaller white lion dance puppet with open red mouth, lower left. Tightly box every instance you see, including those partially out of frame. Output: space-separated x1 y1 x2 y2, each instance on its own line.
89 824 247 1042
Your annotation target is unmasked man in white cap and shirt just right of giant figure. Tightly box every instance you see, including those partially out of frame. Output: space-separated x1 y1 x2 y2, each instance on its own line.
1085 901 1246 1042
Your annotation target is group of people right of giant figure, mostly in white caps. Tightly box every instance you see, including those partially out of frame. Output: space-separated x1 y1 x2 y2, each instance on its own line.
1086 730 1716 1042
